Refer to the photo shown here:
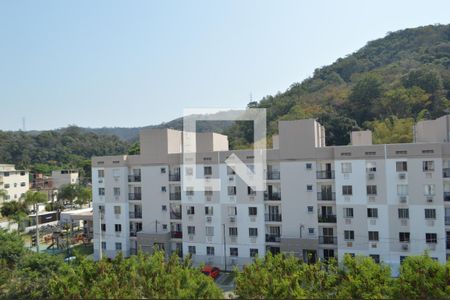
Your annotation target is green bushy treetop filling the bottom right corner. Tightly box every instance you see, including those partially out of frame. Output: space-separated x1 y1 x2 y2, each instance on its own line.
394 253 450 299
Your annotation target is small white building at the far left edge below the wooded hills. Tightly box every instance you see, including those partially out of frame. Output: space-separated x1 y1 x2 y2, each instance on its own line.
0 164 29 203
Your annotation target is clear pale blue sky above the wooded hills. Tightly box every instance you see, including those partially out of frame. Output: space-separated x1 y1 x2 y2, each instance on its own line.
0 0 450 130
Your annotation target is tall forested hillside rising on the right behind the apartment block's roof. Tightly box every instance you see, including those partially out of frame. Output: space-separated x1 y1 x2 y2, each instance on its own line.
227 25 450 148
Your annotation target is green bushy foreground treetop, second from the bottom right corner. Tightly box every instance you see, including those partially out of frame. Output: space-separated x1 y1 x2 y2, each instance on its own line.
337 254 392 299
